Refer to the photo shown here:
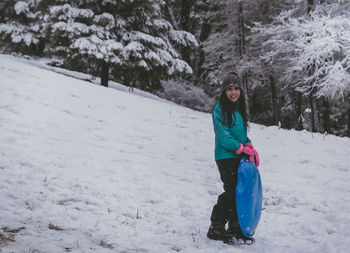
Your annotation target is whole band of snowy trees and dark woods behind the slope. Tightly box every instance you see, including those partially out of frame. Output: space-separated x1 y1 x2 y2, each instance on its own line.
0 0 350 137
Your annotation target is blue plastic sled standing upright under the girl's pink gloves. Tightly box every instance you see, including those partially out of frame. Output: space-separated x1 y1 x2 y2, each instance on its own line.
236 157 262 238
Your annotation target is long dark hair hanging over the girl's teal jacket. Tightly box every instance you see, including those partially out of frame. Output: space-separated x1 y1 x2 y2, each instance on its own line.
219 90 249 129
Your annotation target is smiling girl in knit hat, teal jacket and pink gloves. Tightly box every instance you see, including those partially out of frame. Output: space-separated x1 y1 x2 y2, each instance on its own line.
207 72 259 242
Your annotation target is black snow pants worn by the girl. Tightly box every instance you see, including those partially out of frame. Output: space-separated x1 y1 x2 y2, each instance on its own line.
210 158 241 224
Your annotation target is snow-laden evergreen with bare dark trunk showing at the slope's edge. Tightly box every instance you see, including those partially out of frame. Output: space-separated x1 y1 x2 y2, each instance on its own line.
45 1 119 86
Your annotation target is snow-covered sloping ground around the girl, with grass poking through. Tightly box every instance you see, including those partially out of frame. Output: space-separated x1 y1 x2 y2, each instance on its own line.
0 55 350 253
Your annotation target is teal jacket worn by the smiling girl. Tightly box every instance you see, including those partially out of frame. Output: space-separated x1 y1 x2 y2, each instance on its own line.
212 102 251 160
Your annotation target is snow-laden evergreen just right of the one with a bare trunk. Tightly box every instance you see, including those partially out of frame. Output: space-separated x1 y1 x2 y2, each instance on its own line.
114 0 198 89
